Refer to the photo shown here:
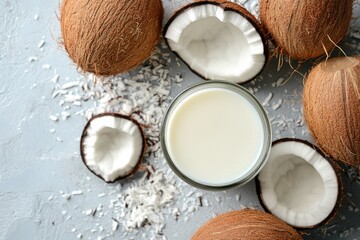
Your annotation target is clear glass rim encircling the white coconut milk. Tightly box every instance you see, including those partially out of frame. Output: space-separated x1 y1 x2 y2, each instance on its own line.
160 81 272 191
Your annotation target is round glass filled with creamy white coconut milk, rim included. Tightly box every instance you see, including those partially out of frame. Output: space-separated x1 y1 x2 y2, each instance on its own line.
161 81 272 191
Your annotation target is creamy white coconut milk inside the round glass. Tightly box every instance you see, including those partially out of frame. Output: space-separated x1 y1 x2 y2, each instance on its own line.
165 88 264 186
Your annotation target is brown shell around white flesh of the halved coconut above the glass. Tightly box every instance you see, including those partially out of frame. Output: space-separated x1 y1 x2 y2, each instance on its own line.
163 0 269 84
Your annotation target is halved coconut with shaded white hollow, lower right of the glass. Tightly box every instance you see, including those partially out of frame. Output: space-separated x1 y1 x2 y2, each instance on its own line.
257 139 341 228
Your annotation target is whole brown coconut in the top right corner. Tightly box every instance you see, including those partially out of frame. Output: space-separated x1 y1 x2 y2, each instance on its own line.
260 0 353 60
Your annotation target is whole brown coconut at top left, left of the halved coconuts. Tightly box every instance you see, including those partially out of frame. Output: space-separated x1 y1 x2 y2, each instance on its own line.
60 0 163 75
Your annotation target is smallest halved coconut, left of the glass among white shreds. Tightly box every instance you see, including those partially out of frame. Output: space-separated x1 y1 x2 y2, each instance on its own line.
80 113 145 183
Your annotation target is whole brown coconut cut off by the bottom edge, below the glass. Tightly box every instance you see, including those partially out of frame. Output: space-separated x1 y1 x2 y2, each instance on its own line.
192 209 302 240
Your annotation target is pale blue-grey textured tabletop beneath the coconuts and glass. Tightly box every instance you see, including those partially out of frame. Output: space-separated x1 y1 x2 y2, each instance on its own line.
0 0 360 240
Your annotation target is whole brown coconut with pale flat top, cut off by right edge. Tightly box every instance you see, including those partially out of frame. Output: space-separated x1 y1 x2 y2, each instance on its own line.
304 56 360 168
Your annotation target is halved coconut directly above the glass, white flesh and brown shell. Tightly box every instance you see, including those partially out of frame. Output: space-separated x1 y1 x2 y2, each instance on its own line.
164 0 268 83
